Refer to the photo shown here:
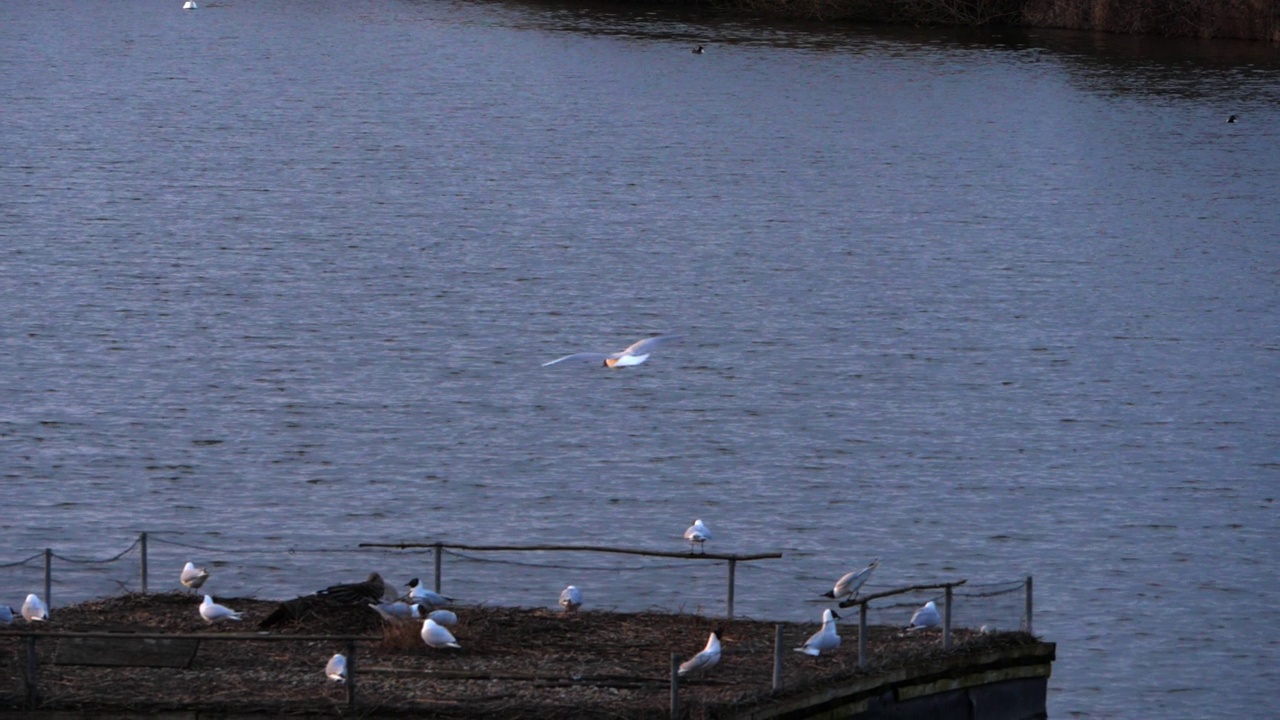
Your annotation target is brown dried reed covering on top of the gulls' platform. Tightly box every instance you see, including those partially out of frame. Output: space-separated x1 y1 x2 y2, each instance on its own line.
0 593 1037 719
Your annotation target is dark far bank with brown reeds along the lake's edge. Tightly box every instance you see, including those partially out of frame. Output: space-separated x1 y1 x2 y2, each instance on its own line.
668 0 1280 42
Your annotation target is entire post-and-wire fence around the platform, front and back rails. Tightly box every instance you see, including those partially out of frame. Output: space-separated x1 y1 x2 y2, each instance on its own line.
0 533 1033 716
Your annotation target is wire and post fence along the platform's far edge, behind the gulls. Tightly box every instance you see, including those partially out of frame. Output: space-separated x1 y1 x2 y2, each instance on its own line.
0 532 1032 630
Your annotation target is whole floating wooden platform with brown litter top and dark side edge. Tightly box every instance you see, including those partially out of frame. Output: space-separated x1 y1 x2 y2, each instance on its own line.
0 593 1055 720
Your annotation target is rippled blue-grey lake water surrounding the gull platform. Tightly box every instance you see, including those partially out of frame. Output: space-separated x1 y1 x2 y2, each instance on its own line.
0 0 1280 717
